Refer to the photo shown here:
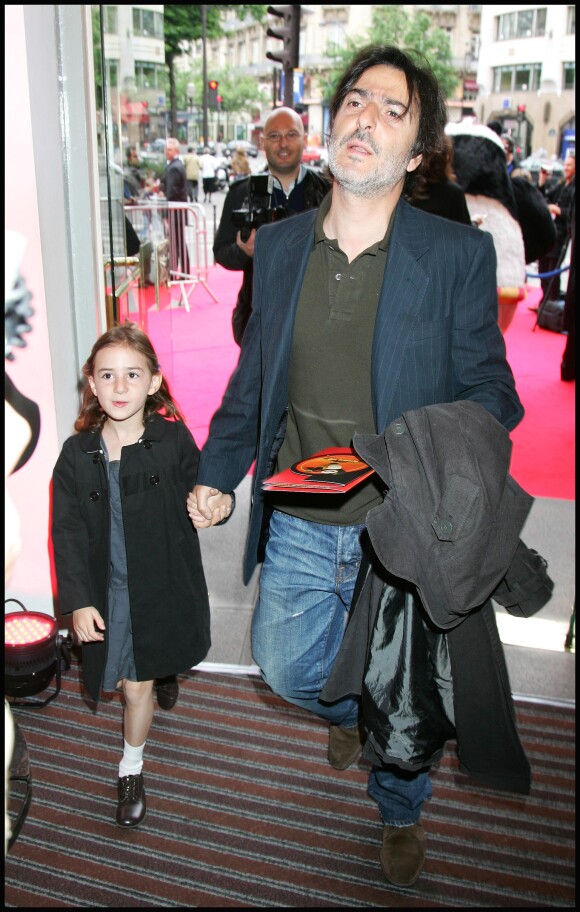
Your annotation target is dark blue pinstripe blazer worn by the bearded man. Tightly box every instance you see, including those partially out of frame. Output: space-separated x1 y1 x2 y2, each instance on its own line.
197 199 524 582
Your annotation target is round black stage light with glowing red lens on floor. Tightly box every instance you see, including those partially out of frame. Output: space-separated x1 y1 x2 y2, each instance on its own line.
4 599 72 706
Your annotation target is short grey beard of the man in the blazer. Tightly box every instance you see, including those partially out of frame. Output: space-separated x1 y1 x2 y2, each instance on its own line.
328 130 413 199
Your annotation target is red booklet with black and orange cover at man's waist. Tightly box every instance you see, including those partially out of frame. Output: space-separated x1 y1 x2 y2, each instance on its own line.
262 447 374 494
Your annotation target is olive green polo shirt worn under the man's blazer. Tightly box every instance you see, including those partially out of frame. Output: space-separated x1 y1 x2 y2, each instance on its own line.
270 194 393 525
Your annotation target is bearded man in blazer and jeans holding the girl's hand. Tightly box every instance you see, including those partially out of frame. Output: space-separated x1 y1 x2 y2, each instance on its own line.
188 46 523 886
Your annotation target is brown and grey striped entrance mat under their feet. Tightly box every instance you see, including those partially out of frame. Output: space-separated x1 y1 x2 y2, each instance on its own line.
5 663 575 909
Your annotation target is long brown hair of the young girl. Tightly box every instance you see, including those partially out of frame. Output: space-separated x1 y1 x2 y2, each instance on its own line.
75 322 185 431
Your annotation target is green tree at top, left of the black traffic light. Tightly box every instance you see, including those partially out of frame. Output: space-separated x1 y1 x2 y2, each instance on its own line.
163 3 266 136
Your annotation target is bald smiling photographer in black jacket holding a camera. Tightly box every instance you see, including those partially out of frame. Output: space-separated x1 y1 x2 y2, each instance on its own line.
213 108 330 345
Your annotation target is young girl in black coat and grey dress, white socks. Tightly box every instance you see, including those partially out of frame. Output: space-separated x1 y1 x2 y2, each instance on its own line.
52 323 210 827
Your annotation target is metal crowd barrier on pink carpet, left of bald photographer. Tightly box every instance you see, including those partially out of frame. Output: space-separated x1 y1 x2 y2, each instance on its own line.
125 200 218 310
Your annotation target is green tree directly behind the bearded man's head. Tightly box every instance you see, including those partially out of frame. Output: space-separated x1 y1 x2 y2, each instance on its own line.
320 4 459 104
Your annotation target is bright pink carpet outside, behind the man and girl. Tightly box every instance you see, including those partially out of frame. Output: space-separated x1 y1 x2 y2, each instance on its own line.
148 266 576 500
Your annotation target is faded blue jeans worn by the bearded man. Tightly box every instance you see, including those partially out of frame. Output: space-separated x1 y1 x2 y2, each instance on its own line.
252 510 431 826
